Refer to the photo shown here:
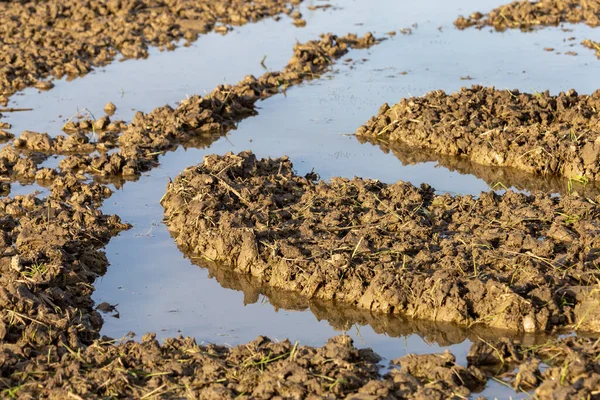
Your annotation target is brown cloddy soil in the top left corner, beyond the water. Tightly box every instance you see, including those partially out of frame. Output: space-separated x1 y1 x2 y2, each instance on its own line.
0 0 301 105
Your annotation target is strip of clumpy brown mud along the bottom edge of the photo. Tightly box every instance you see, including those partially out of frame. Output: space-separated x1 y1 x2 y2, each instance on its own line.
7 318 600 399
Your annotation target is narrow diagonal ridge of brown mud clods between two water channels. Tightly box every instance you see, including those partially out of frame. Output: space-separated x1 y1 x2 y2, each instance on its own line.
0 33 379 187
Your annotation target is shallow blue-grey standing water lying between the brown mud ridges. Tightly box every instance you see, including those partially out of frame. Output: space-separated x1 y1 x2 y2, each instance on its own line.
5 0 600 397
